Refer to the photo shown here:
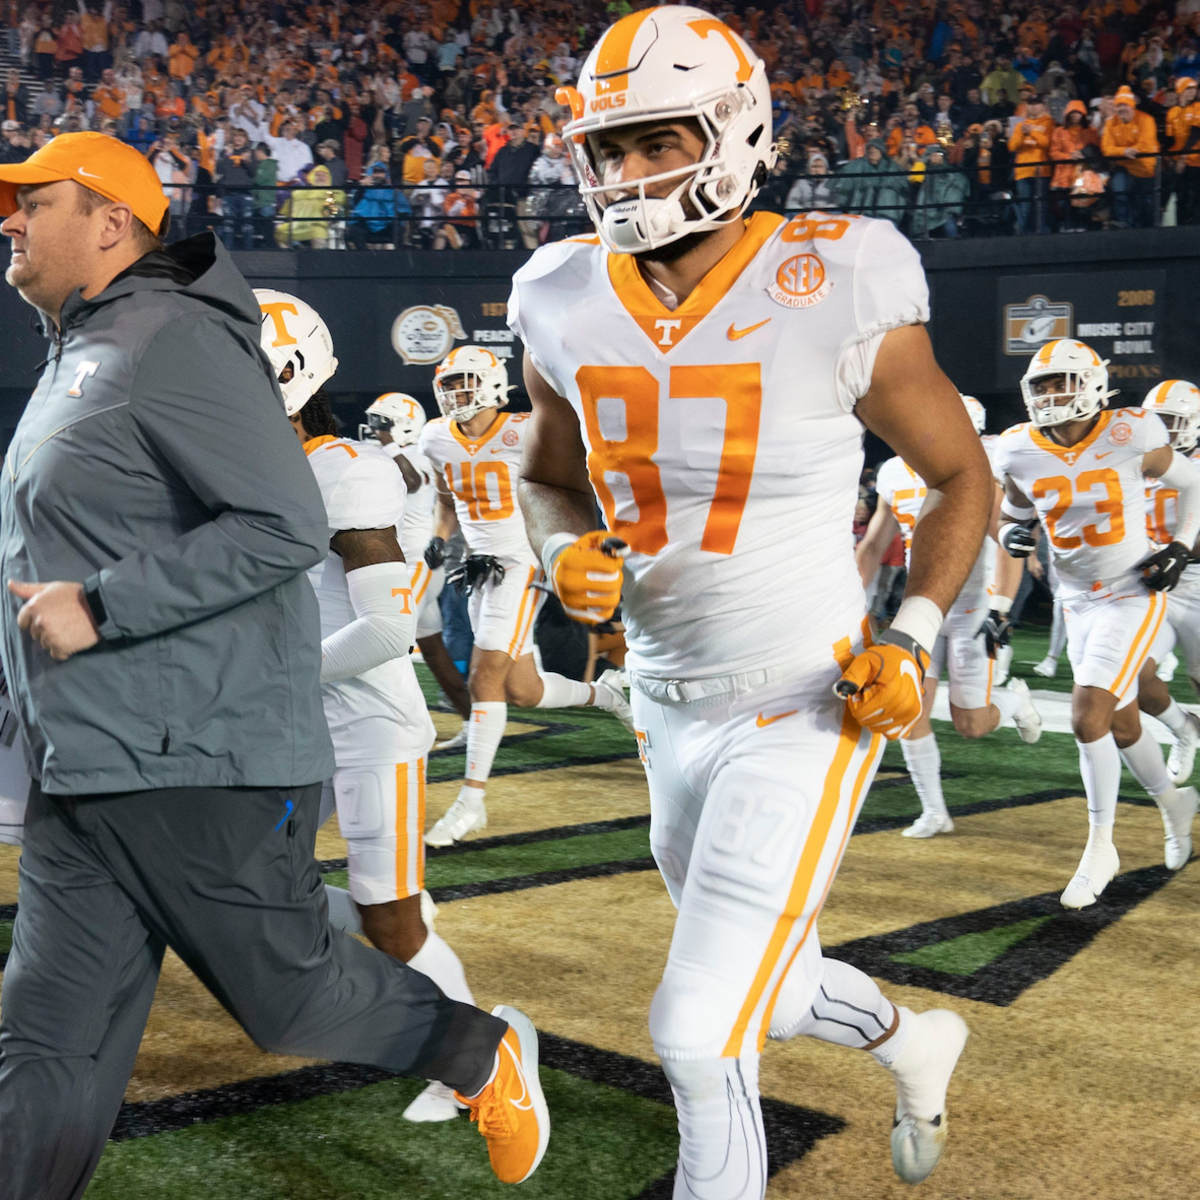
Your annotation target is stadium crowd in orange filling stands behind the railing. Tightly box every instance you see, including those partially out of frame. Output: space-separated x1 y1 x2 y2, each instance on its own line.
0 0 1200 248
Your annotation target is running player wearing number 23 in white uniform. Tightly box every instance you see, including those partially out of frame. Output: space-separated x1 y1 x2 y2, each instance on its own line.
995 338 1200 908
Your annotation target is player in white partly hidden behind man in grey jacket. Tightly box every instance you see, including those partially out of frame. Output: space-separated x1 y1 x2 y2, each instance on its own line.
256 289 487 1121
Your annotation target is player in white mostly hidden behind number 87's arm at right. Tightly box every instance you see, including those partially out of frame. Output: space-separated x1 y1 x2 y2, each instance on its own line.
856 396 1042 838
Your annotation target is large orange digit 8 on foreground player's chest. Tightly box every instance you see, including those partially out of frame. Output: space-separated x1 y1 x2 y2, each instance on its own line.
575 367 667 554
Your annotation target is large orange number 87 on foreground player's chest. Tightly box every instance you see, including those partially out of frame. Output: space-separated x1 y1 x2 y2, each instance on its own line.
575 362 762 554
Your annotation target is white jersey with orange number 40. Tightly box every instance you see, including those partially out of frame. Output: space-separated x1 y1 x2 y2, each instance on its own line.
416 412 536 563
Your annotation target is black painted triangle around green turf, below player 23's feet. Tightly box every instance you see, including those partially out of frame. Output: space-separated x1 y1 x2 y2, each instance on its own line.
827 866 1176 1008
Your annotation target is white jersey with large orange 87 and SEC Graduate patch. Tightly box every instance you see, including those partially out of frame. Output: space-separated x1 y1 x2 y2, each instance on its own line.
509 212 929 679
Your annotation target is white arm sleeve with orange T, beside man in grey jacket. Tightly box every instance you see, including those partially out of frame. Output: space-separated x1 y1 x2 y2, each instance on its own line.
320 563 415 683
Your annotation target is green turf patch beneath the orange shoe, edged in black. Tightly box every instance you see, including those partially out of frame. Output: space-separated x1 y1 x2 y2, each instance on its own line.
88 1069 678 1200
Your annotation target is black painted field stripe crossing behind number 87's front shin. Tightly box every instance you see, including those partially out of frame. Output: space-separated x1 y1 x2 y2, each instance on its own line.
538 1033 846 1200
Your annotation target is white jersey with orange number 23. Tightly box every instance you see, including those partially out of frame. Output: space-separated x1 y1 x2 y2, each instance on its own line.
994 408 1168 599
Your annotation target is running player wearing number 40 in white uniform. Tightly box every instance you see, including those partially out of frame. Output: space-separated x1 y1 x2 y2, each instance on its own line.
418 346 632 846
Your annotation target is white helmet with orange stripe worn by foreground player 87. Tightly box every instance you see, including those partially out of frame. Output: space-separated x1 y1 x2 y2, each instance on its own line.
557 5 776 254
